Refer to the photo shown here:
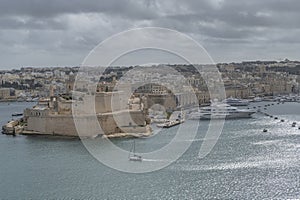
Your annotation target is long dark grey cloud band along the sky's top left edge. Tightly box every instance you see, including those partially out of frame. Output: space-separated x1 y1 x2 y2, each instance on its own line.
0 0 154 19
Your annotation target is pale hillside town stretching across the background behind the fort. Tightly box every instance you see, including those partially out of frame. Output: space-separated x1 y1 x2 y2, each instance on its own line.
0 59 300 107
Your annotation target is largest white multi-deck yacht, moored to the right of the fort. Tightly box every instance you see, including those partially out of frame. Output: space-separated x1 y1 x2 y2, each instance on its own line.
192 102 256 120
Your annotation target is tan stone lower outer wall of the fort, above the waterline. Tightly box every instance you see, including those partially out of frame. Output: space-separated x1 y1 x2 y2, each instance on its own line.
25 110 146 137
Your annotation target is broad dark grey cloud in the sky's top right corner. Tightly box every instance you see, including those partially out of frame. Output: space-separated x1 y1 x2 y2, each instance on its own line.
155 0 300 39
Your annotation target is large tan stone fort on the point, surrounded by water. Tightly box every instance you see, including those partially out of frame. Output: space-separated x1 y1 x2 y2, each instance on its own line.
23 92 151 137
